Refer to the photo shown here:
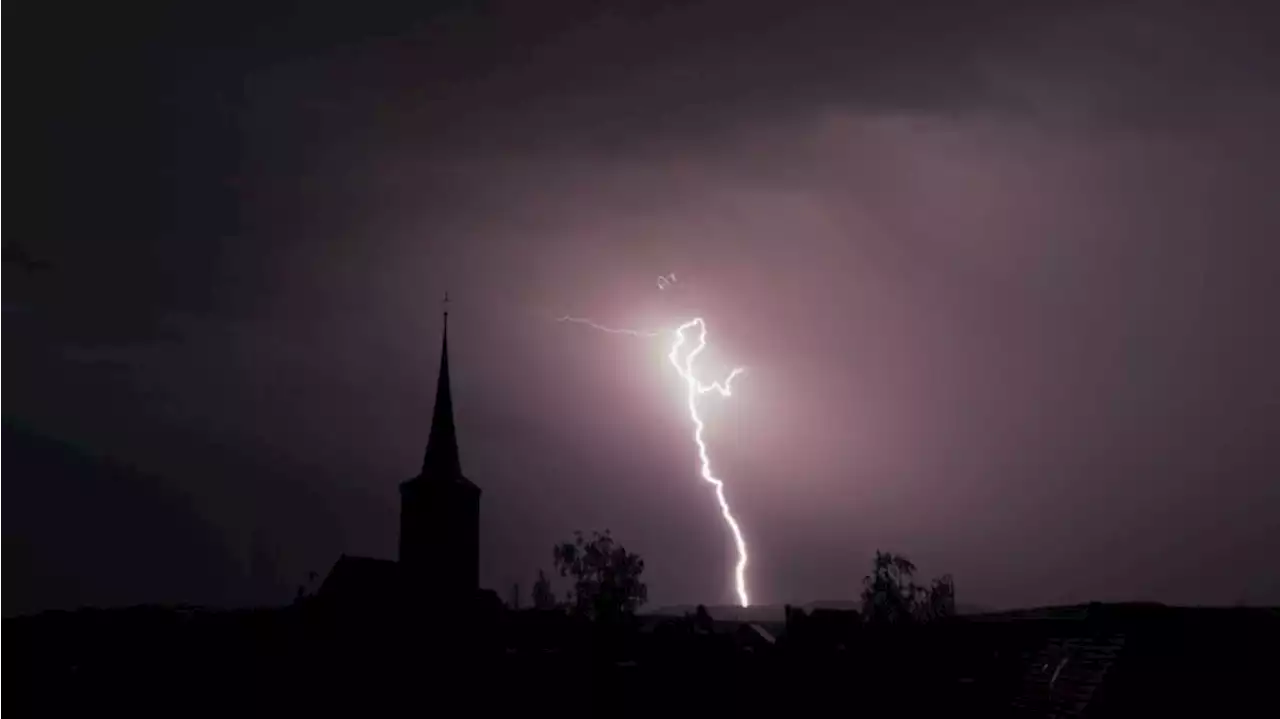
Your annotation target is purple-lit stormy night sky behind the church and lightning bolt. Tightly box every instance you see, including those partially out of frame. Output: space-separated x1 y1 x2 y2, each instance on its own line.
0 0 1280 612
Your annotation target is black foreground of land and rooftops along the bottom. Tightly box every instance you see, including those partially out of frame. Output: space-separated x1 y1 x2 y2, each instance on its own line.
0 592 1280 716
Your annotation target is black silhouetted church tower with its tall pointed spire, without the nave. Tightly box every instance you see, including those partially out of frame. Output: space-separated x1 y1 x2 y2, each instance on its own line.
399 299 480 601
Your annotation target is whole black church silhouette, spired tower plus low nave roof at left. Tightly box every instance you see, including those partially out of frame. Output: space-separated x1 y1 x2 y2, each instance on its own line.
316 311 497 610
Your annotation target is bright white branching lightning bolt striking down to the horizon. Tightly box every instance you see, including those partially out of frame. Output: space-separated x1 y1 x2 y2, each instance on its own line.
557 310 750 606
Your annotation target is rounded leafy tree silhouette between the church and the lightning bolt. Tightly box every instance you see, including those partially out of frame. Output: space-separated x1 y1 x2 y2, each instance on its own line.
552 530 649 620
